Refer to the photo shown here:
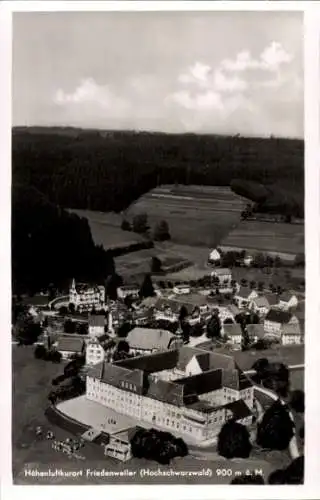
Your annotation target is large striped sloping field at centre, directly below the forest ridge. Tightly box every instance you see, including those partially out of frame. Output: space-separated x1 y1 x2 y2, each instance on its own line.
127 185 245 248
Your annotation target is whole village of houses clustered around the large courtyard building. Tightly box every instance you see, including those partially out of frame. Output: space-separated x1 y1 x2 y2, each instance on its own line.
11 244 304 470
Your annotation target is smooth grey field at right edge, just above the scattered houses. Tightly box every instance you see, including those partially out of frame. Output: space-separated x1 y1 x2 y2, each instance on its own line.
220 221 304 262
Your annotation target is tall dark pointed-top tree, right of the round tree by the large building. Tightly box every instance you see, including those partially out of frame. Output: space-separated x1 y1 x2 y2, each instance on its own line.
257 400 294 451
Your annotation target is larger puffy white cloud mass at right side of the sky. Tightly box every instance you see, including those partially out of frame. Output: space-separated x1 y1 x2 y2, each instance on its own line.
167 42 303 134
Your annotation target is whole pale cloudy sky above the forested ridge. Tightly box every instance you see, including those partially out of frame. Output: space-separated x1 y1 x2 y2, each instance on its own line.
12 11 303 138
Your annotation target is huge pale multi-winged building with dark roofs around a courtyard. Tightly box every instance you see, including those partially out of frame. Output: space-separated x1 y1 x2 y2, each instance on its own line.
86 347 253 442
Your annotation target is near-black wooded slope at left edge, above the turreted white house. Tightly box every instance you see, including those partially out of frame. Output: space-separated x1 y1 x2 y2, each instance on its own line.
12 184 113 293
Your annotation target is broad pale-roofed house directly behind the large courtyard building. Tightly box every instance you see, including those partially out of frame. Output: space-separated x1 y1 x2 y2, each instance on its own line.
126 327 178 356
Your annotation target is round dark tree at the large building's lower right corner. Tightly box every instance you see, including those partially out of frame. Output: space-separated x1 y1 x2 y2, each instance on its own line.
217 420 252 459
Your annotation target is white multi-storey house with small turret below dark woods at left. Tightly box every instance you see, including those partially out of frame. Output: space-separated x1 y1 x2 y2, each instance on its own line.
69 279 105 312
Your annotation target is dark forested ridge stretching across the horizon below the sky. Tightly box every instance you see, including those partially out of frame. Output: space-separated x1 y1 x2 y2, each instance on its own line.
12 127 304 212
